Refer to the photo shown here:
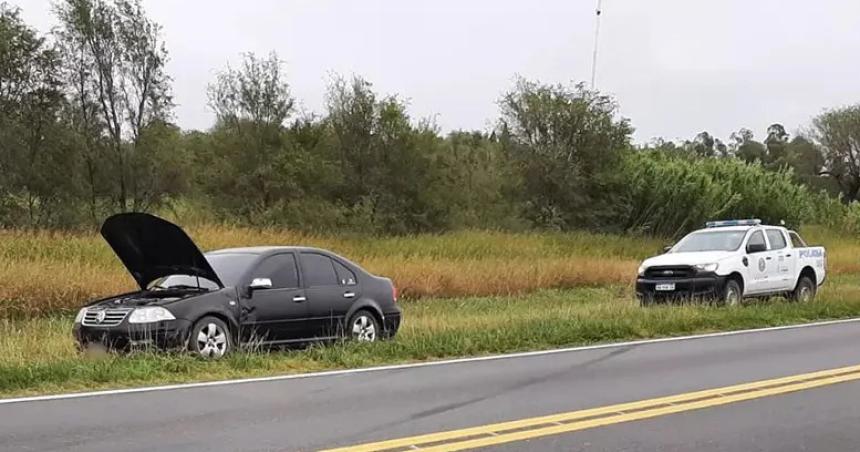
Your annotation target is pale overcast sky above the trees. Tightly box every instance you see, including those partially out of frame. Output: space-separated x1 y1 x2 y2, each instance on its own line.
7 0 860 141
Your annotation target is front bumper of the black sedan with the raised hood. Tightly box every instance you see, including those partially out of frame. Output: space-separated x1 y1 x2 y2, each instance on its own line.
73 319 191 350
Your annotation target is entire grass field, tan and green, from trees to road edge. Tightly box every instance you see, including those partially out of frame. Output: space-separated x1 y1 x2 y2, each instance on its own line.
0 226 860 396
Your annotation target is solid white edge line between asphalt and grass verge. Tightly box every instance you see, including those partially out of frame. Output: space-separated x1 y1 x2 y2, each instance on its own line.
0 317 860 405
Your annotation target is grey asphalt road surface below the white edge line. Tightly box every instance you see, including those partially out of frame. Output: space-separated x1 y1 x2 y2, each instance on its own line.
0 322 860 451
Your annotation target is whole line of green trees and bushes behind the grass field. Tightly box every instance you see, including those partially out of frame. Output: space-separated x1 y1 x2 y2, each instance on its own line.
0 0 860 235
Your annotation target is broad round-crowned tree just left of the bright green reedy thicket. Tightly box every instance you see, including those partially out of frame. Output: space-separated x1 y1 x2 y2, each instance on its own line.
499 79 633 228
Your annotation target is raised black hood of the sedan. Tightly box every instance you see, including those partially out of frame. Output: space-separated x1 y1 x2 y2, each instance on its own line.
101 213 224 289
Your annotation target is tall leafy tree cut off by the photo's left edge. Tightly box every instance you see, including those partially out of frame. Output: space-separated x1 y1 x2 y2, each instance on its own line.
0 3 77 226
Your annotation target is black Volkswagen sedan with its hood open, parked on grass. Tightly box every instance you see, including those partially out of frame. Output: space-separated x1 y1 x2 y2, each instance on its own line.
74 213 400 358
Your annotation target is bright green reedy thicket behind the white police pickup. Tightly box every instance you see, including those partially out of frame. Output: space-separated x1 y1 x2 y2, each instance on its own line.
618 151 814 236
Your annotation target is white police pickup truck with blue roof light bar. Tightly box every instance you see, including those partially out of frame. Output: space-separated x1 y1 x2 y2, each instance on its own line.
636 220 827 305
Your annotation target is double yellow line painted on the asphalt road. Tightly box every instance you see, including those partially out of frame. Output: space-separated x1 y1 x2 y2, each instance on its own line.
320 366 860 452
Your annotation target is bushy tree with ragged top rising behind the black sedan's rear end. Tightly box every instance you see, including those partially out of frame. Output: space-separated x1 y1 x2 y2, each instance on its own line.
325 76 450 233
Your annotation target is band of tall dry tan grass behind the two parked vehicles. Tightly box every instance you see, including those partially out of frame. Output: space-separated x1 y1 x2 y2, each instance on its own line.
0 225 860 318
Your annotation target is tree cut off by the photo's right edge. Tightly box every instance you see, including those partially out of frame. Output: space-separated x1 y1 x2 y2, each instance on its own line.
811 104 860 202
